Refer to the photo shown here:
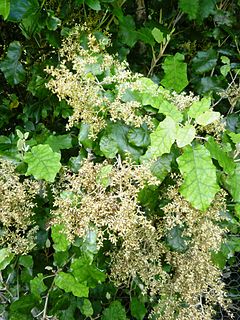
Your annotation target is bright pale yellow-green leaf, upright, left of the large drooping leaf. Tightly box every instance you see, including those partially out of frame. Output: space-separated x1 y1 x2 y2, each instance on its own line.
148 116 177 157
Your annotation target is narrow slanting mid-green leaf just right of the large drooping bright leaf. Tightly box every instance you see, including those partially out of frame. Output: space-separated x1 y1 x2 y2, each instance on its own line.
205 137 236 174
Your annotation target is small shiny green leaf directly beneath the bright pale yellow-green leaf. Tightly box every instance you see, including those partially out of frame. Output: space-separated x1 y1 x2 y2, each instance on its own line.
151 154 173 181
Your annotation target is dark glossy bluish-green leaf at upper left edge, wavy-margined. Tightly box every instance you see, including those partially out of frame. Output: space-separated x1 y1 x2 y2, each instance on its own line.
0 41 26 86
